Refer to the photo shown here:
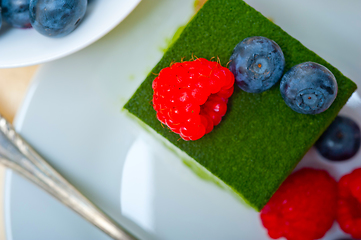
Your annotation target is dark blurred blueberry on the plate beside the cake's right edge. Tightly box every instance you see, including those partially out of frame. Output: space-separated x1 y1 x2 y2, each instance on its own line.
315 116 361 161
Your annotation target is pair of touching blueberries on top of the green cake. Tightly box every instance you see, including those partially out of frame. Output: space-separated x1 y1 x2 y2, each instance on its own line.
229 36 338 114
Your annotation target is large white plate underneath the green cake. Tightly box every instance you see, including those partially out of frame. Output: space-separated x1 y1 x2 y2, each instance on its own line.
5 0 361 240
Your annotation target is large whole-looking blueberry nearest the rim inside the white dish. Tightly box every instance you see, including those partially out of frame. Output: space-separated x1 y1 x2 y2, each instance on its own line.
30 0 88 37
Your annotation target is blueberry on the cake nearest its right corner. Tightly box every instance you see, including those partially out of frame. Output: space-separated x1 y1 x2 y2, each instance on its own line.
280 62 338 114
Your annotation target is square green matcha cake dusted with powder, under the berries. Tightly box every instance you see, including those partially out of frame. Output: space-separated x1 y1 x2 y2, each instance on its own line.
125 0 356 211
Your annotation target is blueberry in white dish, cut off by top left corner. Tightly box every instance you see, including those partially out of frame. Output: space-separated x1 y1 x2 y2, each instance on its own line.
1 0 31 28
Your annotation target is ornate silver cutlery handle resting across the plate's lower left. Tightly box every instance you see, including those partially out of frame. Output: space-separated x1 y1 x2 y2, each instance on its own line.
0 115 135 240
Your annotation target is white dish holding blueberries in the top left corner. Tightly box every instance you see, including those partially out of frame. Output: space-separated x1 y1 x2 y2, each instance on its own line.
0 0 141 68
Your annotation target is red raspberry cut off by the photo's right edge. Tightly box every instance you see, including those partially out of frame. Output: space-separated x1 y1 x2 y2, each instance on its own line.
337 168 361 239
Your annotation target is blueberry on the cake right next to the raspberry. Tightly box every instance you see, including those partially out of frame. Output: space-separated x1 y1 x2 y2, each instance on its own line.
229 37 285 93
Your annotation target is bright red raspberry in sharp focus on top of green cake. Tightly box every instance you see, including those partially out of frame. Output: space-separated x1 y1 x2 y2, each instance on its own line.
152 58 234 141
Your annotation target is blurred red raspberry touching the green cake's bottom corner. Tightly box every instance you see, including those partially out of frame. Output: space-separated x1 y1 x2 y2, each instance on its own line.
261 168 337 240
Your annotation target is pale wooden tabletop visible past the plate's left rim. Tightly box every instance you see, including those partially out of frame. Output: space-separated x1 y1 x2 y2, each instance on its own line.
0 66 37 240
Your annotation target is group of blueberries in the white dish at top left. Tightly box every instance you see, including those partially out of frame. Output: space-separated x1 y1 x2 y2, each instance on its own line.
0 0 88 37
